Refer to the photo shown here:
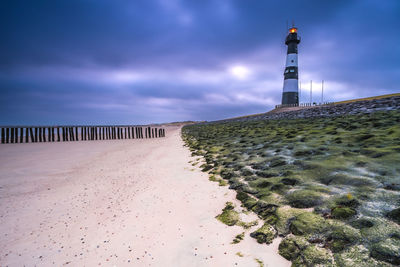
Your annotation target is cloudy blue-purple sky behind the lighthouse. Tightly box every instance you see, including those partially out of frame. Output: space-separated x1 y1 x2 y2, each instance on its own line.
0 0 400 125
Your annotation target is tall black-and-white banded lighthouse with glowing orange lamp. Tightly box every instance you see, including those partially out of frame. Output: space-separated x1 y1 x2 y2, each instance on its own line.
282 26 300 105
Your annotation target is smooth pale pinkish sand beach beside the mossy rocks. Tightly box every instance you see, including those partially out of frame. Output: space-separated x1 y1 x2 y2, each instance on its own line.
0 126 290 266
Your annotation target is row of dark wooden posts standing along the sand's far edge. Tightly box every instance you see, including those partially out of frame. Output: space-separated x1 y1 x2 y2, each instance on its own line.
0 126 165 144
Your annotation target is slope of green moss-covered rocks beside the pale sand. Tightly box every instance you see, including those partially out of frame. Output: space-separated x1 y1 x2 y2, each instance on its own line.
182 111 400 266
